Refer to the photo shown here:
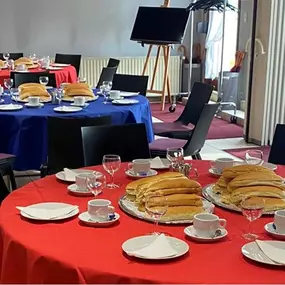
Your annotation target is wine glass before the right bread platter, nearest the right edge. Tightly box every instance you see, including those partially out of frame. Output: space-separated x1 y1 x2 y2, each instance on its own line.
240 197 264 240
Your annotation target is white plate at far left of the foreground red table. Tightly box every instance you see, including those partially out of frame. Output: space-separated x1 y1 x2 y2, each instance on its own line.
20 202 79 221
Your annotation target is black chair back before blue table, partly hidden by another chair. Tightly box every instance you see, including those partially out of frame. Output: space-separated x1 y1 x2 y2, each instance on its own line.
41 116 112 177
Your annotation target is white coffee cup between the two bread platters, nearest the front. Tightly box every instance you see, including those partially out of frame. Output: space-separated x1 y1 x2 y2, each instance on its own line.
193 213 227 238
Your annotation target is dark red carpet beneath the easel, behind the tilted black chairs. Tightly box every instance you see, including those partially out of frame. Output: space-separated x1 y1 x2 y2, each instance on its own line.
150 103 243 139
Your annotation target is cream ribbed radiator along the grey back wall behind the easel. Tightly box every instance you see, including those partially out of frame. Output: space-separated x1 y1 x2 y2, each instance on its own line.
80 56 181 96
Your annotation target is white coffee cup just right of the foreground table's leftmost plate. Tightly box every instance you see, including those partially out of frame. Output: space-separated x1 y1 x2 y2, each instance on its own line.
88 199 115 221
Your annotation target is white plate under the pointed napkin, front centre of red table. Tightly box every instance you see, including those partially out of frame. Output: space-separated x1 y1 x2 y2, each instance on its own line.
122 235 189 260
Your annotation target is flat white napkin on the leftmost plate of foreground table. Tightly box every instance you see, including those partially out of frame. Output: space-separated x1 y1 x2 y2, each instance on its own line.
16 206 78 220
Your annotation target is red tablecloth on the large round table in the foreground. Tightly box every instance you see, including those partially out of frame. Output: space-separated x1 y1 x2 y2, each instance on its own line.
0 161 285 284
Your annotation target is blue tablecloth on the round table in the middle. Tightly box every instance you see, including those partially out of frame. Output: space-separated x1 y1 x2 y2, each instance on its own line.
0 93 154 171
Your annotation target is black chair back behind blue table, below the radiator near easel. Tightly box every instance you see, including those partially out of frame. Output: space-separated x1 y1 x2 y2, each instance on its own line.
112 74 148 96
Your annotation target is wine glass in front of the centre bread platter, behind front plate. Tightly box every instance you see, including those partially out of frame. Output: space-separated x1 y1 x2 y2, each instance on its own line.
145 194 168 235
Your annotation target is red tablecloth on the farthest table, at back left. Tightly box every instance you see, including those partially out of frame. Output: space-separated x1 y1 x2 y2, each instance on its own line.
0 66 77 87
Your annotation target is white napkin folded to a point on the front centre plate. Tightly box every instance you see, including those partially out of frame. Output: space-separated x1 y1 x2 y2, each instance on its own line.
128 234 177 259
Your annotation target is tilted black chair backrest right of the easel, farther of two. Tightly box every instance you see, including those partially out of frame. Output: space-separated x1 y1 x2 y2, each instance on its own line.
176 82 214 125
